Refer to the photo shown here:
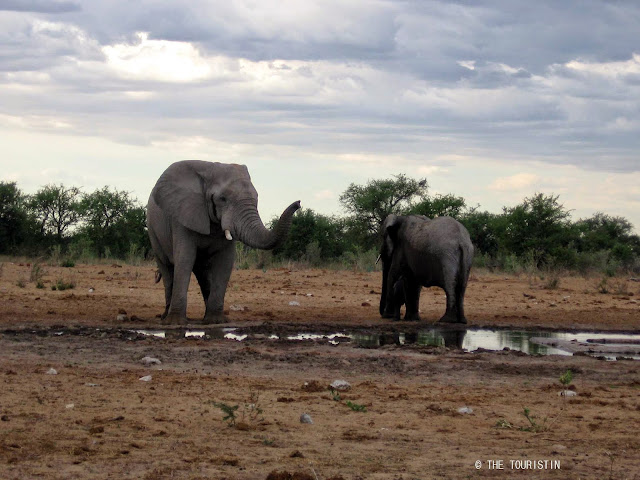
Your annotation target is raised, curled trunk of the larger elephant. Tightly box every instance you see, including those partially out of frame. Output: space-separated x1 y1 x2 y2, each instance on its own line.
234 201 300 250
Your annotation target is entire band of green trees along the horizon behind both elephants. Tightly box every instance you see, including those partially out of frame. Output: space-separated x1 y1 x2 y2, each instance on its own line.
0 174 640 274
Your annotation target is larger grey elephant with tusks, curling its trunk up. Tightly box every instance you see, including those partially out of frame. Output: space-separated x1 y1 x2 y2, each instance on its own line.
147 160 300 324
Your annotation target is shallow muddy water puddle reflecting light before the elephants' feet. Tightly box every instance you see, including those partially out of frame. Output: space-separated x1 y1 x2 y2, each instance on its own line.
132 327 640 360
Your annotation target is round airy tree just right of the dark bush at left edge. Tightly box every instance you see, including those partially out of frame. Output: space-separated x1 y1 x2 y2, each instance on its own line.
28 184 80 243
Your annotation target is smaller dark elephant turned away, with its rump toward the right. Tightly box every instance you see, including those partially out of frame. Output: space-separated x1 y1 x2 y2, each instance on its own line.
380 215 473 323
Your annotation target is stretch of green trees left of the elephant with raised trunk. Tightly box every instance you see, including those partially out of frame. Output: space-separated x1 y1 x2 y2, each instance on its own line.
0 182 150 260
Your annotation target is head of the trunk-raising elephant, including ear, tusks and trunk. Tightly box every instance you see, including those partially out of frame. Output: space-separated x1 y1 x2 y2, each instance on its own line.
152 160 300 250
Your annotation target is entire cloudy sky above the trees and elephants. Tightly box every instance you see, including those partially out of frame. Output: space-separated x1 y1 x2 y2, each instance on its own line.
0 0 640 231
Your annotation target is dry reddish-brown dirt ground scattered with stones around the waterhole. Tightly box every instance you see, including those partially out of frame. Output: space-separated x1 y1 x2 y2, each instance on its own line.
0 259 640 480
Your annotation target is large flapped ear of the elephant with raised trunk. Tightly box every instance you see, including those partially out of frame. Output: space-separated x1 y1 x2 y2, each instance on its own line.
153 160 211 235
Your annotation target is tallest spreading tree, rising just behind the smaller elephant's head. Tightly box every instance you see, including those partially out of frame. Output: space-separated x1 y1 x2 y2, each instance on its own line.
340 174 429 242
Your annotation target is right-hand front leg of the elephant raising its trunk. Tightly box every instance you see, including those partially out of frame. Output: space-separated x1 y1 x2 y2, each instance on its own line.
203 248 235 324
